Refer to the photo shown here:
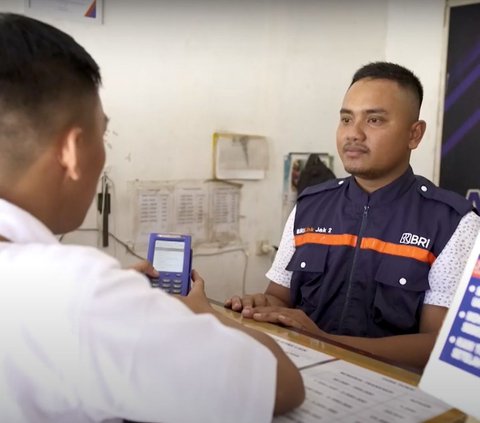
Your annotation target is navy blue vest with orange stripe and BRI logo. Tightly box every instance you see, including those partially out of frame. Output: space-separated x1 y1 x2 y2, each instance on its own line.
287 168 472 337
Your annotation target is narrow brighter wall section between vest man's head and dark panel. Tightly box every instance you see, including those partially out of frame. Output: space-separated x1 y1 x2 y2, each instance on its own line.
385 0 447 183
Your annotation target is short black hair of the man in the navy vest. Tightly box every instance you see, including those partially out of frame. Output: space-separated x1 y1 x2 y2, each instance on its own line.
350 62 423 109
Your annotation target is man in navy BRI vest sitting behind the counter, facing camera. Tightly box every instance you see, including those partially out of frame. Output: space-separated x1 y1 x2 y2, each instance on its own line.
225 62 480 367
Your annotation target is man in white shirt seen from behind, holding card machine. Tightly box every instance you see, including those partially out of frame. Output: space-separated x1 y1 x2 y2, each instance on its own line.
0 14 304 423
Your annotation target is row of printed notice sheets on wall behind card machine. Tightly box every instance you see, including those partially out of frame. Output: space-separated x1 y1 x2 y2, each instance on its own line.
128 180 242 252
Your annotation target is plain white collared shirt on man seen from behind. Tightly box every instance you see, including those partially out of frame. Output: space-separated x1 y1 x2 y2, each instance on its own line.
0 200 276 423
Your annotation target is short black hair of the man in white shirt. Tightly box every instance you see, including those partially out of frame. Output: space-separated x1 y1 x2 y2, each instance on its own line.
0 13 101 171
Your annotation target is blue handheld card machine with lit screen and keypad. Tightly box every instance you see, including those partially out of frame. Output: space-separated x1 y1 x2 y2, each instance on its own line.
147 233 192 295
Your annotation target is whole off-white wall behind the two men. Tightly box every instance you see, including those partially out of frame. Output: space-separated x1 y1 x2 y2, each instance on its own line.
0 0 444 299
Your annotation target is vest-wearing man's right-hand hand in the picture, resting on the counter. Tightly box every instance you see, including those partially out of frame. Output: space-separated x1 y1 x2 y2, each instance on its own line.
248 307 324 335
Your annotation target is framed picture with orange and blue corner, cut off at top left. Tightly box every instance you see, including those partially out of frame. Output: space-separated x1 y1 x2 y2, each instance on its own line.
25 0 103 24
